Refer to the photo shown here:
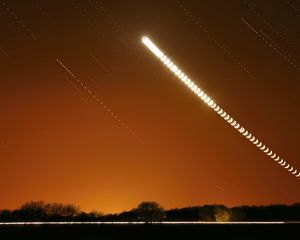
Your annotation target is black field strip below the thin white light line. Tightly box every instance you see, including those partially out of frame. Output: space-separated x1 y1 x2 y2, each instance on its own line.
0 224 300 240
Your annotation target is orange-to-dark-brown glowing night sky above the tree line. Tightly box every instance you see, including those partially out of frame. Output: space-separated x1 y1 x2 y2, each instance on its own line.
0 0 300 213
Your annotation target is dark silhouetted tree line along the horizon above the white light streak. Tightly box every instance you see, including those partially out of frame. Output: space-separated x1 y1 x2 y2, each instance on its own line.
0 201 300 223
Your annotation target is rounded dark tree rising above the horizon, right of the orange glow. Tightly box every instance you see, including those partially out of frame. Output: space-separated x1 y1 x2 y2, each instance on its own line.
134 202 165 223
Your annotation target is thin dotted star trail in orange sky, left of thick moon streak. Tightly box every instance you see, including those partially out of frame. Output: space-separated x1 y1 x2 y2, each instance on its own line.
56 59 135 135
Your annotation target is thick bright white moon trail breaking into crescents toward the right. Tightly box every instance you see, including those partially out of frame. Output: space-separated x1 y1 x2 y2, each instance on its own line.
142 36 300 179
